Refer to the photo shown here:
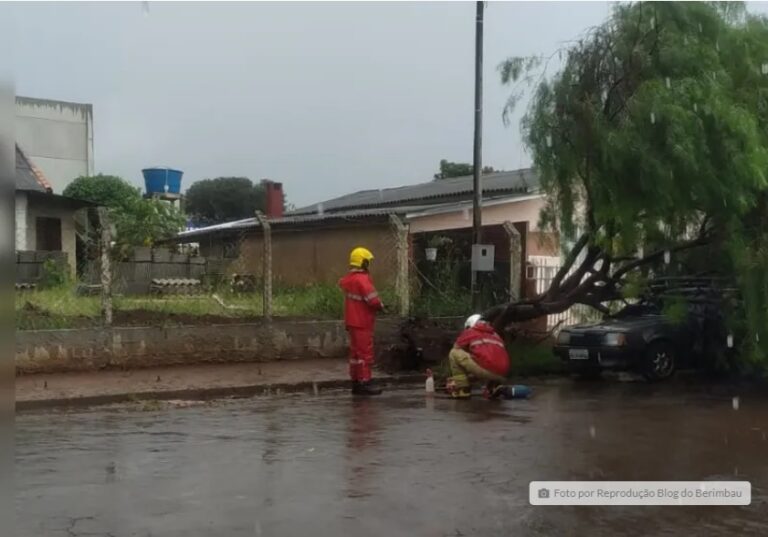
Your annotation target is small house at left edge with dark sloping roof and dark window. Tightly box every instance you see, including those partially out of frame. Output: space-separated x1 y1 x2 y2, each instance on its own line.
15 145 92 276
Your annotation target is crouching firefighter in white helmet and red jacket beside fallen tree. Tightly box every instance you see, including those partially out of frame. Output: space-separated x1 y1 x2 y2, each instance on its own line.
446 314 509 399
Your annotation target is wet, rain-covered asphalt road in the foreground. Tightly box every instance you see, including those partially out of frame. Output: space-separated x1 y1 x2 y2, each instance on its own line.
16 382 768 537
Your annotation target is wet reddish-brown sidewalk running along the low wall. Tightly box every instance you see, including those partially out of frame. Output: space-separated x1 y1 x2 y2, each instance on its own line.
16 358 423 410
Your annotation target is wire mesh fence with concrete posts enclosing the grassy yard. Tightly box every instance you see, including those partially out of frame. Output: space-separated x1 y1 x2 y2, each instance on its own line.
16 215 410 329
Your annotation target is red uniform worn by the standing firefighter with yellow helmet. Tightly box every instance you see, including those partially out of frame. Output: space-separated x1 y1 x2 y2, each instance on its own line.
339 269 384 382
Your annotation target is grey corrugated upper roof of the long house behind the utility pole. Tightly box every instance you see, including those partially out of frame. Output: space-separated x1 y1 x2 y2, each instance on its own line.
289 168 539 215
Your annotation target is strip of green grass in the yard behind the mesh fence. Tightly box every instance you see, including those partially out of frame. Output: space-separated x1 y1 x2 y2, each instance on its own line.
15 285 395 330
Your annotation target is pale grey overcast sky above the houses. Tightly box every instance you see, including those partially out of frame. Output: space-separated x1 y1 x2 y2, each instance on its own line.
6 2 768 206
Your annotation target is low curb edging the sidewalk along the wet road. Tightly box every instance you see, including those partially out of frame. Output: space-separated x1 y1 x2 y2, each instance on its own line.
16 374 424 412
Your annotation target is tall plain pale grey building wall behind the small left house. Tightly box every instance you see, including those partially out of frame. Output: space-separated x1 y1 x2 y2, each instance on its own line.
16 97 93 194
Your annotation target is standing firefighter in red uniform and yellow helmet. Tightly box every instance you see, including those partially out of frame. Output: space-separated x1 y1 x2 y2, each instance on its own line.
339 248 384 395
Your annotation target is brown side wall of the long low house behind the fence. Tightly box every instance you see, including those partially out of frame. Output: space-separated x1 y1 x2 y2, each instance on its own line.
200 222 397 286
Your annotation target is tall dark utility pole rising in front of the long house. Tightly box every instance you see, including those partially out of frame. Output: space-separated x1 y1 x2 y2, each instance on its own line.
472 2 485 311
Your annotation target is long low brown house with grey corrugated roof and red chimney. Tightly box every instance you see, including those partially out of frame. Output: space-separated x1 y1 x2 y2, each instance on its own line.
175 169 559 298
